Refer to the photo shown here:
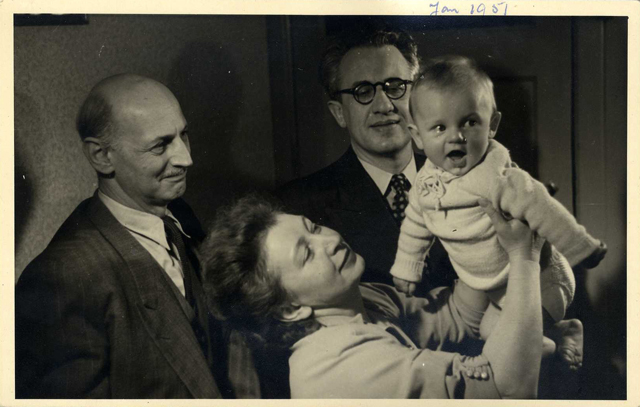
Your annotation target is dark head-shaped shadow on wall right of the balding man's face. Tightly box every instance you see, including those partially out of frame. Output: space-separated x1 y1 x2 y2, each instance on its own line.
167 41 266 225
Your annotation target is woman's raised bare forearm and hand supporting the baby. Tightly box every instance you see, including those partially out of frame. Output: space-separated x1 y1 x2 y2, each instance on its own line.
480 200 543 398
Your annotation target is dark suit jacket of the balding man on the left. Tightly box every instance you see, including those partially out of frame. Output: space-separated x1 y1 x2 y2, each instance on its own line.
16 195 232 398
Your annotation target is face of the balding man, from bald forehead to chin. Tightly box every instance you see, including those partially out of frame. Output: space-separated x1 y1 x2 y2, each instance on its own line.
109 84 193 214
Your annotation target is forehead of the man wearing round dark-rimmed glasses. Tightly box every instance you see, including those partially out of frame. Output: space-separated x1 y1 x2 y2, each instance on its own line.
338 45 411 86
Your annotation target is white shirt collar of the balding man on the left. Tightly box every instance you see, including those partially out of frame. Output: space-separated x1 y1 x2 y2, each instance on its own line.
98 190 190 250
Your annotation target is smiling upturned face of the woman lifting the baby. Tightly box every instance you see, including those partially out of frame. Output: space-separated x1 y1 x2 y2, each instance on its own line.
265 214 364 309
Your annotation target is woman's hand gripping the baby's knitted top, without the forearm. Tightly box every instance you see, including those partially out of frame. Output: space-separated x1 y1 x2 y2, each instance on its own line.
478 199 544 262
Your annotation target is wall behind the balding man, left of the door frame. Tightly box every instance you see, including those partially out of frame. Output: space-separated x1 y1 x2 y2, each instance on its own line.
14 15 274 279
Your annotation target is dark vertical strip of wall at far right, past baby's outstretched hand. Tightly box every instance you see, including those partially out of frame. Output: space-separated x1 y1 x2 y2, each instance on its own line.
573 18 633 399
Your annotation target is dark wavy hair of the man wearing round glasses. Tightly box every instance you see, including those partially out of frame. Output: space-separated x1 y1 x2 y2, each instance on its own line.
320 27 420 100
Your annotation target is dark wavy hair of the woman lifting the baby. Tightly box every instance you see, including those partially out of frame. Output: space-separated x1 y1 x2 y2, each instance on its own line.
200 194 319 349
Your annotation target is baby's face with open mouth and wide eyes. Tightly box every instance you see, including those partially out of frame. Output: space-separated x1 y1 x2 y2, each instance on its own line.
409 86 500 176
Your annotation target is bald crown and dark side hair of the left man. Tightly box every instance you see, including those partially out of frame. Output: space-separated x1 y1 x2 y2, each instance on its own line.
76 73 177 147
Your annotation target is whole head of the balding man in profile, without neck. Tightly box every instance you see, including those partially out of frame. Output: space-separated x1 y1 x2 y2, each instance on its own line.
78 74 193 216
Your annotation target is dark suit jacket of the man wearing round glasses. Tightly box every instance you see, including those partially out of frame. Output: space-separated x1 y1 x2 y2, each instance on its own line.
276 147 455 293
